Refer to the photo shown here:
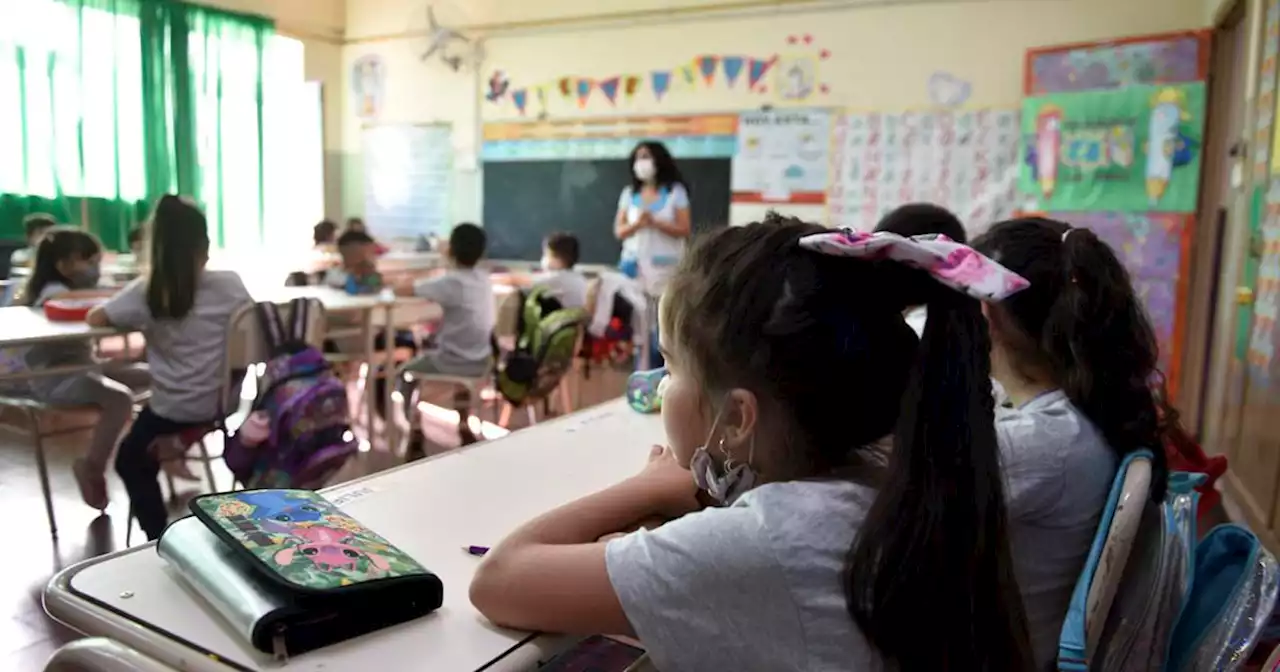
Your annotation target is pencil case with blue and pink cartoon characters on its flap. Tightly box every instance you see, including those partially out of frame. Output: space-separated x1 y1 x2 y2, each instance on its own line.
156 490 443 659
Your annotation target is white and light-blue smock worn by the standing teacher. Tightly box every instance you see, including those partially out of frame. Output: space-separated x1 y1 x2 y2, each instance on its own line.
618 184 689 297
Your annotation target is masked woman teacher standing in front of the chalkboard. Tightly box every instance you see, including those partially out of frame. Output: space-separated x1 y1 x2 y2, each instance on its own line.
613 141 692 369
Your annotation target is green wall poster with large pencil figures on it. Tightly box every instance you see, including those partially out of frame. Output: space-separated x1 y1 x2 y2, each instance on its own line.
1019 83 1204 212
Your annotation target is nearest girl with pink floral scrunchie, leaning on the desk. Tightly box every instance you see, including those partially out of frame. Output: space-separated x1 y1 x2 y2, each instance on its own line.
471 215 1030 672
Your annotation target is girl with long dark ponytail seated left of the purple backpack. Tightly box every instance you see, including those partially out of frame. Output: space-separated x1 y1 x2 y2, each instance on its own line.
87 195 253 539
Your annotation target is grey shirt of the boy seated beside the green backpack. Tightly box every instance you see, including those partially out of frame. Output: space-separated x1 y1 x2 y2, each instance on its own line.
413 269 494 366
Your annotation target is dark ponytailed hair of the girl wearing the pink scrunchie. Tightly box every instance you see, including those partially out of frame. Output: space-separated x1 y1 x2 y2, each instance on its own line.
660 214 1032 672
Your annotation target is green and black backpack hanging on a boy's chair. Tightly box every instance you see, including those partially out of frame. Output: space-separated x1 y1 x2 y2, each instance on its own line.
497 288 588 406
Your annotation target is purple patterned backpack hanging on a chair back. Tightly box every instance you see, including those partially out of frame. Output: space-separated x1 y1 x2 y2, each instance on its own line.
223 298 358 489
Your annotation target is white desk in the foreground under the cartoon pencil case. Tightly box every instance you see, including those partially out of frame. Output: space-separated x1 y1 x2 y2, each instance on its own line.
45 399 663 672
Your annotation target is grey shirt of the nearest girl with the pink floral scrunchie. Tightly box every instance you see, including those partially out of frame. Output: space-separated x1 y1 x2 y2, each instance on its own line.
605 480 885 672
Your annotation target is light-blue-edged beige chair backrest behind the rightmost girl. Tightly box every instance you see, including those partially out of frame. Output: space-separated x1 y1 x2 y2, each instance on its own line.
1059 451 1151 669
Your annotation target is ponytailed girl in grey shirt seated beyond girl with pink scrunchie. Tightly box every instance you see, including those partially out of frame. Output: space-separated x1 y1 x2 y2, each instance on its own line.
974 218 1181 669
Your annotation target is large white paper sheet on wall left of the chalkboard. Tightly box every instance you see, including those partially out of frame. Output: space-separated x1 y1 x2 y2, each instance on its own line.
361 124 453 239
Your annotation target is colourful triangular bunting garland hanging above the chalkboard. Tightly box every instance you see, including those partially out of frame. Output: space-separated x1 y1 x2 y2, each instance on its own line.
486 36 831 112
